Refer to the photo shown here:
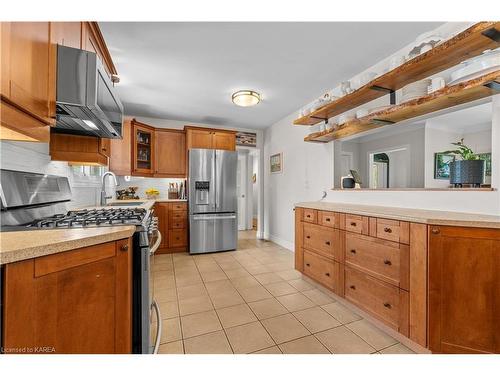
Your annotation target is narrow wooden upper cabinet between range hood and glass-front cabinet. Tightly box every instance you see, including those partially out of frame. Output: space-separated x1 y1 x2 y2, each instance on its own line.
109 118 133 176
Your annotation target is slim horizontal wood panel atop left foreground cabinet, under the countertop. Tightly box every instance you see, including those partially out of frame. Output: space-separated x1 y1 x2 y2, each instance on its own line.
35 242 115 277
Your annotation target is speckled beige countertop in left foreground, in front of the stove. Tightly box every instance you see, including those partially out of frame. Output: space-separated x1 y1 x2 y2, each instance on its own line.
0 225 135 264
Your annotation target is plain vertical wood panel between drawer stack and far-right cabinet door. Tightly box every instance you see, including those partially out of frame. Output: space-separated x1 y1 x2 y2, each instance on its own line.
409 223 428 347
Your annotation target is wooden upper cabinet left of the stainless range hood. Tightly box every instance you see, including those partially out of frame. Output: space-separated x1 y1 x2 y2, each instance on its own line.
2 22 53 124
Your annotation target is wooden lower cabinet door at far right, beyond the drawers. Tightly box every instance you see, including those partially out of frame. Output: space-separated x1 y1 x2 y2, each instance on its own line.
429 226 500 353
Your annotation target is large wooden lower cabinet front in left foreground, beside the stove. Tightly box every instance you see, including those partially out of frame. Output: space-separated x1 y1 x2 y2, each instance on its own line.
2 239 132 354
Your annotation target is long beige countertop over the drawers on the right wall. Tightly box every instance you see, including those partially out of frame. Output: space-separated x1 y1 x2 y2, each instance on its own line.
295 202 500 229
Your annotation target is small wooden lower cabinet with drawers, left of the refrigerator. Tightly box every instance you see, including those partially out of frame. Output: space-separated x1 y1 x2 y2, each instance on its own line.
155 202 188 254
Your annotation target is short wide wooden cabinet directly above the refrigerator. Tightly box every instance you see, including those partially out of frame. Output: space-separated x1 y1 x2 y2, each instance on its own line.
185 126 236 151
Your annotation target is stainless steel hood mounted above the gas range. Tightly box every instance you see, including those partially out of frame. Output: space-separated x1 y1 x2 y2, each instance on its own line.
53 46 123 138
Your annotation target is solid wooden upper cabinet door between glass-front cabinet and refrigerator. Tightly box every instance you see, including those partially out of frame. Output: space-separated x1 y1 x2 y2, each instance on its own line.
155 130 186 177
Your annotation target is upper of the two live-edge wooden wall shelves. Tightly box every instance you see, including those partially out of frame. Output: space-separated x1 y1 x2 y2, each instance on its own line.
294 22 500 125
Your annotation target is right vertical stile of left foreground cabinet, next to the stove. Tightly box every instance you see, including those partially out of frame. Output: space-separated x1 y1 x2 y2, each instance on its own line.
114 238 133 354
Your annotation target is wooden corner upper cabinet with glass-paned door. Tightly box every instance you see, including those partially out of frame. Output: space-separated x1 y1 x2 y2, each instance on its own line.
132 120 155 177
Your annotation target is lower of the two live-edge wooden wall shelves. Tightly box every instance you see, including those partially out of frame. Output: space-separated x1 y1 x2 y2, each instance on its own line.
304 70 500 142
